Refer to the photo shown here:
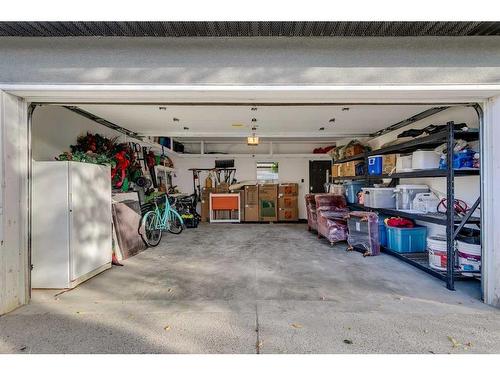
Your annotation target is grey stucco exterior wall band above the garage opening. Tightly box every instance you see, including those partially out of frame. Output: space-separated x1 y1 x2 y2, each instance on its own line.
0 37 500 85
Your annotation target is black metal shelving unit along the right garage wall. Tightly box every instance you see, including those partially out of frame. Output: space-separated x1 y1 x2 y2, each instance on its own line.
333 122 481 290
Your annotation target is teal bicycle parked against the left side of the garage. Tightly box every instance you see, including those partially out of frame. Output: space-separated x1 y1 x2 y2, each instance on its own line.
140 194 184 247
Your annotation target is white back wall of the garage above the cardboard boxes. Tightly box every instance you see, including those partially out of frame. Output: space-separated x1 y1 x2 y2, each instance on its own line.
173 155 324 219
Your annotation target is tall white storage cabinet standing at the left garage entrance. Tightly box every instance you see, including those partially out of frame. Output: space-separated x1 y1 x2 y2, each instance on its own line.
31 161 112 289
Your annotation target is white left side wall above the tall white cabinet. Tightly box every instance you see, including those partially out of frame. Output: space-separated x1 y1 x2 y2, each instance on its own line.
32 105 126 161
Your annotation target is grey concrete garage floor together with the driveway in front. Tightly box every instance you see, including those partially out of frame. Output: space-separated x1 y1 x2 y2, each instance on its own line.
0 224 500 353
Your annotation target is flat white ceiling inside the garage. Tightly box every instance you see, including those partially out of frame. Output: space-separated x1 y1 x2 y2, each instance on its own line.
79 104 432 138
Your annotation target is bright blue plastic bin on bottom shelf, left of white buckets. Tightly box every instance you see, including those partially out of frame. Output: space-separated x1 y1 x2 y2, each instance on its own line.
385 225 427 253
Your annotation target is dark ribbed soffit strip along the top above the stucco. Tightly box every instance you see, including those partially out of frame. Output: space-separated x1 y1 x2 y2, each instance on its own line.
0 21 500 37
